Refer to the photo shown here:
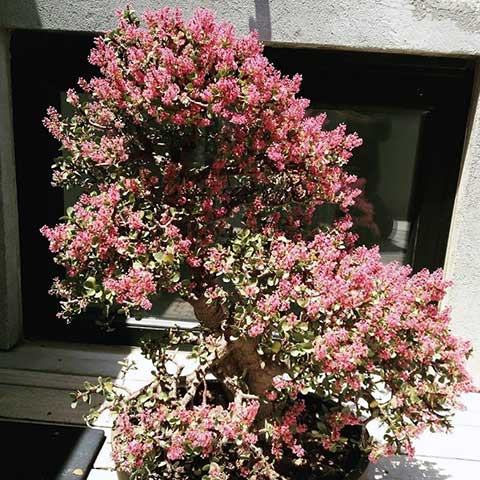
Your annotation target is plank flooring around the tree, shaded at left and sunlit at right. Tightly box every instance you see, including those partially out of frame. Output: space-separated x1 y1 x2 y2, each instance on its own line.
0 342 480 480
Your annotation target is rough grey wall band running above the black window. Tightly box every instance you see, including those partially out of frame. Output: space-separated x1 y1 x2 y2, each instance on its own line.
0 0 480 54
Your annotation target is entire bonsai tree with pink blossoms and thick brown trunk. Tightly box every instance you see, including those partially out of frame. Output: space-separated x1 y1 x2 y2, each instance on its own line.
42 8 473 480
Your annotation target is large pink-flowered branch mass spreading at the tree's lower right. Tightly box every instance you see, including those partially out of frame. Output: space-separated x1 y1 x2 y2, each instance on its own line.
202 230 472 464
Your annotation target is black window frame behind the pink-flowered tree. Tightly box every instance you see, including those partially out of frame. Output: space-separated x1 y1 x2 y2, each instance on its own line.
11 30 475 344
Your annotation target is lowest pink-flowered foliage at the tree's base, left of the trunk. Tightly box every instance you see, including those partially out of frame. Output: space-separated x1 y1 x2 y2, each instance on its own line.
75 346 282 480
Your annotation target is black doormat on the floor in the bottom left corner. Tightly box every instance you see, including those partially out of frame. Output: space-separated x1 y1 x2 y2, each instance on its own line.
0 421 105 480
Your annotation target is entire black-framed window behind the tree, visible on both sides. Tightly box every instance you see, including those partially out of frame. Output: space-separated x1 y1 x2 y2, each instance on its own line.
11 31 474 344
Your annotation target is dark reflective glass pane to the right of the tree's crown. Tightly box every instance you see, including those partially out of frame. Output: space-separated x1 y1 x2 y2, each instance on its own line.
309 105 427 263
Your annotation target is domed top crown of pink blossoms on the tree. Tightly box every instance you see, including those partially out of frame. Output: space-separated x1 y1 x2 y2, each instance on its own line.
45 9 361 248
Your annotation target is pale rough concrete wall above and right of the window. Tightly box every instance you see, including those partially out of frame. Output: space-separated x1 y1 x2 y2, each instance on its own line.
0 0 480 383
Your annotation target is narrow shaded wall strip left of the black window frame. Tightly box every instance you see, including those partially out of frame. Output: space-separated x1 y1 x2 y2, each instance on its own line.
0 30 22 349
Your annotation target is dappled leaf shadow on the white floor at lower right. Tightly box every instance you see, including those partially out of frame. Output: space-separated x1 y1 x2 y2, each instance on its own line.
365 456 451 480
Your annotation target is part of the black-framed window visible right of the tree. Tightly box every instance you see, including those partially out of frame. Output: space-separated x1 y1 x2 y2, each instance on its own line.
266 47 474 270
